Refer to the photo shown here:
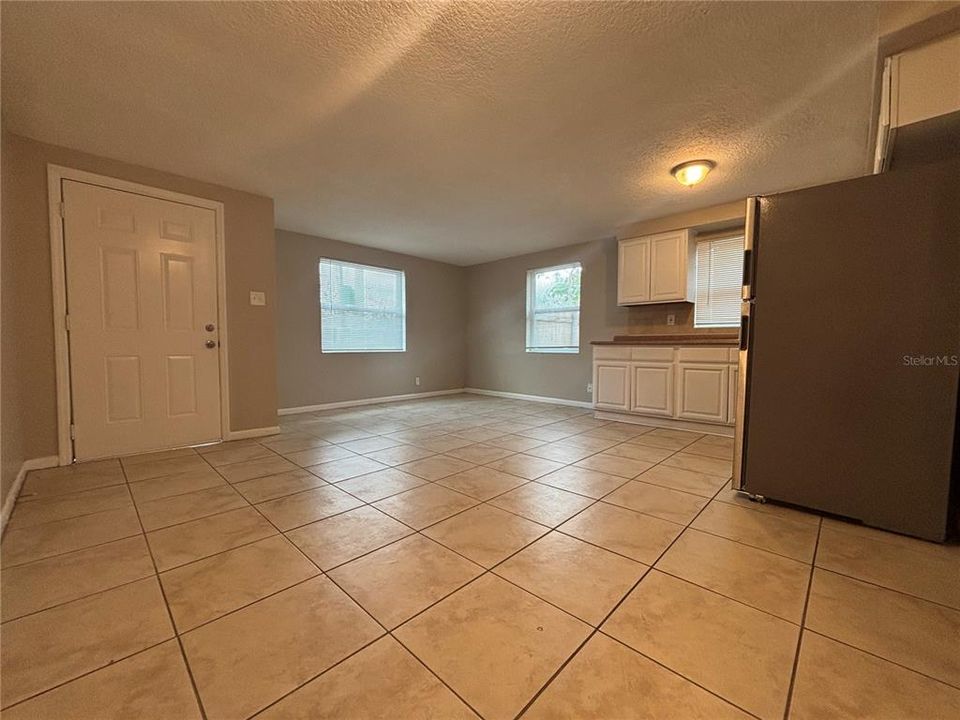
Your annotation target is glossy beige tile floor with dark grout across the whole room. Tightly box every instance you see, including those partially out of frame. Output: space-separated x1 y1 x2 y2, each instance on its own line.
0 395 960 720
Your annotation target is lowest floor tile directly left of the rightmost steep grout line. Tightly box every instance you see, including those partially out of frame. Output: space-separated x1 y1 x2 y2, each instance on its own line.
602 570 799 720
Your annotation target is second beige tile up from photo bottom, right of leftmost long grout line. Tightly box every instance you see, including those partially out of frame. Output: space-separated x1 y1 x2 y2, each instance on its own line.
160 535 319 632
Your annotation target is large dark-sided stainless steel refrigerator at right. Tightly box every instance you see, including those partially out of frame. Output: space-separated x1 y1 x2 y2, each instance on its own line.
733 162 960 540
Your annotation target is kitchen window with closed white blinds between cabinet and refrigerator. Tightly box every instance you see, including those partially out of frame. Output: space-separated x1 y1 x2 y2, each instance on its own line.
693 235 743 327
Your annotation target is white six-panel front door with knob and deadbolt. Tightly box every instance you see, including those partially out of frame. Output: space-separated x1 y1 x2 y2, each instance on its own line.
63 180 221 460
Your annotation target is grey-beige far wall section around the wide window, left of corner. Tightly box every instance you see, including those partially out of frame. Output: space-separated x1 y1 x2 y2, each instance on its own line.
277 230 466 408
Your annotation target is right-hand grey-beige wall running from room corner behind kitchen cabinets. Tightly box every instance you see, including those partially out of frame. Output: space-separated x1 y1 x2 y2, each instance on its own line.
467 202 745 402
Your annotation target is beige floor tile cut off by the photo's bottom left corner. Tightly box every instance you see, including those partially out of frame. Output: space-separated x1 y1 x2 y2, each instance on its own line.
3 640 201 720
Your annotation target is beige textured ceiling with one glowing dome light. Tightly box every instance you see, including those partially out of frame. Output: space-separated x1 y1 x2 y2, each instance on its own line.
0 2 877 264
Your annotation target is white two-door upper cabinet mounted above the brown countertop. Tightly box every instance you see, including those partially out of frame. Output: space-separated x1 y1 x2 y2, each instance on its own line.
617 230 694 305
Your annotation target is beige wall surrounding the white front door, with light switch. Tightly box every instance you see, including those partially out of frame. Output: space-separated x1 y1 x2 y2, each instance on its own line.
0 133 277 506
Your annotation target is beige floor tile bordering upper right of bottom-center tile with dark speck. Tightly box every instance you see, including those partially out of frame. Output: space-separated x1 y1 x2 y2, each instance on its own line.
494 532 647 625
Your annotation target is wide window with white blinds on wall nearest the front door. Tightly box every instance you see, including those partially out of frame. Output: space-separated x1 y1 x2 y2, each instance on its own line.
320 258 407 353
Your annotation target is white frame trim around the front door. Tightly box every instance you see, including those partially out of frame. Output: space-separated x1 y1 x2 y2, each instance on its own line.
47 164 230 465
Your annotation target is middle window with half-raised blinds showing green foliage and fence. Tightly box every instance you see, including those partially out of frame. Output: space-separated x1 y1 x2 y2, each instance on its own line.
527 263 581 353
